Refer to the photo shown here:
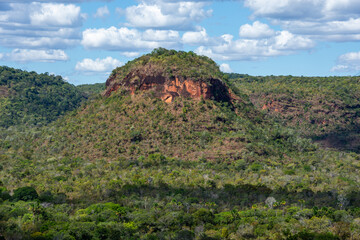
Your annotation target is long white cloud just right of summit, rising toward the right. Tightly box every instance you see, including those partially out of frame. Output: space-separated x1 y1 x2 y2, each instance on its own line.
195 31 315 61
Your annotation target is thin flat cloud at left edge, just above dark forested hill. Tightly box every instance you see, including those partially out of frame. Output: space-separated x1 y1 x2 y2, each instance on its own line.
1 49 69 62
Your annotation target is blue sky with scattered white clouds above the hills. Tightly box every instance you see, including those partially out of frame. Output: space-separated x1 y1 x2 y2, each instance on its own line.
0 0 360 85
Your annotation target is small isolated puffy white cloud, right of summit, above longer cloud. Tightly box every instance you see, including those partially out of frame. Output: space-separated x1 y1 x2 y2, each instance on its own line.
239 21 275 38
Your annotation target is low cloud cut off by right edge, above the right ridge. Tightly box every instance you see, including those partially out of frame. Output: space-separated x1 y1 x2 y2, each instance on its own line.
331 52 360 72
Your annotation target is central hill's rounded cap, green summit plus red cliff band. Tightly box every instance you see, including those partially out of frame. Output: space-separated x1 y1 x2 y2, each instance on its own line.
105 48 236 102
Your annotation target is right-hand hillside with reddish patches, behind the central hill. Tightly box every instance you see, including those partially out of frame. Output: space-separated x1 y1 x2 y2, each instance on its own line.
230 74 360 152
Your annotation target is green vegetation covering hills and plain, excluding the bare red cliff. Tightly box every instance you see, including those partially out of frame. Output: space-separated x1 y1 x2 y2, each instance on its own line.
0 49 360 240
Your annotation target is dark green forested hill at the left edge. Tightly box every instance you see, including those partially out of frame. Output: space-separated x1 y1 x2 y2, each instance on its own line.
0 67 86 128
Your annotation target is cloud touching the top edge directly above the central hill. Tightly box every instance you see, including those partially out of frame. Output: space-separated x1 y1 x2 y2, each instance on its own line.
125 1 212 30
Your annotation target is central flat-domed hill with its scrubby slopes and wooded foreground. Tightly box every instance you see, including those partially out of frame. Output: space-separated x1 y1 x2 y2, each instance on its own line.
0 49 360 240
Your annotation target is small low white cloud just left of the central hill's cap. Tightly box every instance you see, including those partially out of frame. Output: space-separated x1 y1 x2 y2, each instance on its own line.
75 57 123 72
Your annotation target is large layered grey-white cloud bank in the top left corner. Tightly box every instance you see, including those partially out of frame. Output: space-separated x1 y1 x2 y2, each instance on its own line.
0 2 84 49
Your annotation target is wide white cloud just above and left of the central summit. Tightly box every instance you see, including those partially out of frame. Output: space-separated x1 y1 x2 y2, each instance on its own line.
81 27 179 52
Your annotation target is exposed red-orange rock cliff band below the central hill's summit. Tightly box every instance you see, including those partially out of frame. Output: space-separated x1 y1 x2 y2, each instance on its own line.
104 68 236 102
